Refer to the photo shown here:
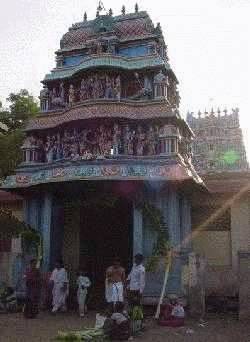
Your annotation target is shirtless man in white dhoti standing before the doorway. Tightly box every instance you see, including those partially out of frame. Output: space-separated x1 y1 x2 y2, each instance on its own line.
105 258 126 306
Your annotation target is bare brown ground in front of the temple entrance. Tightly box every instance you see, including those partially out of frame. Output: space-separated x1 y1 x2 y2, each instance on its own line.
0 313 250 342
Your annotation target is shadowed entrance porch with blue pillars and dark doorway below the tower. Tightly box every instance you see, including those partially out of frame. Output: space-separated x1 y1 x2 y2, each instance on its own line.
20 180 194 303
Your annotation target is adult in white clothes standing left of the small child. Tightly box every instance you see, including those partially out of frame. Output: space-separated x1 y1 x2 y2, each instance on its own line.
50 261 69 313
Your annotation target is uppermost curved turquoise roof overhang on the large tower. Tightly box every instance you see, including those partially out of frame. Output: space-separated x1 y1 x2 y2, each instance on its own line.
43 54 171 83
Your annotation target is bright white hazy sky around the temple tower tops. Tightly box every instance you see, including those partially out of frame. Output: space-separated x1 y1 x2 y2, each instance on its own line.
0 0 250 160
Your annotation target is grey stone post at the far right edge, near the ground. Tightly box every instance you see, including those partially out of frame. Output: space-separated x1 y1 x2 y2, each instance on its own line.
238 251 250 320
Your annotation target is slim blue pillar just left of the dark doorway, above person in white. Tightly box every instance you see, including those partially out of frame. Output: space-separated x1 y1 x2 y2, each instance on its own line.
40 193 52 272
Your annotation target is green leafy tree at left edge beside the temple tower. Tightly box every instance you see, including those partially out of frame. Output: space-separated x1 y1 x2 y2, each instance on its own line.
0 89 39 180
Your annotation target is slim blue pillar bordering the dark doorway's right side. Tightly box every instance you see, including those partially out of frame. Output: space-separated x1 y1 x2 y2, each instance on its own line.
133 202 143 255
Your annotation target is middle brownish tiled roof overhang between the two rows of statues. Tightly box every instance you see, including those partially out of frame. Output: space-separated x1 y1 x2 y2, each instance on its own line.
25 99 189 135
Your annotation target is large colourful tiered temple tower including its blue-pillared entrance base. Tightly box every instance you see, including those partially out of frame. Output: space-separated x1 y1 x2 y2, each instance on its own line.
3 5 204 301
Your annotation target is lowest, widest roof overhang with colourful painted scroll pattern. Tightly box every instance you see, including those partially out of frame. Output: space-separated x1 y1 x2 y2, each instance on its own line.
2 155 205 190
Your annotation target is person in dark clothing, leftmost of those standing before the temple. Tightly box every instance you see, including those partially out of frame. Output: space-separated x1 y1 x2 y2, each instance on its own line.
23 259 42 318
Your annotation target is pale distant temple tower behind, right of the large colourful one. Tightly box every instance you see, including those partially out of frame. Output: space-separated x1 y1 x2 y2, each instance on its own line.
187 108 248 173
